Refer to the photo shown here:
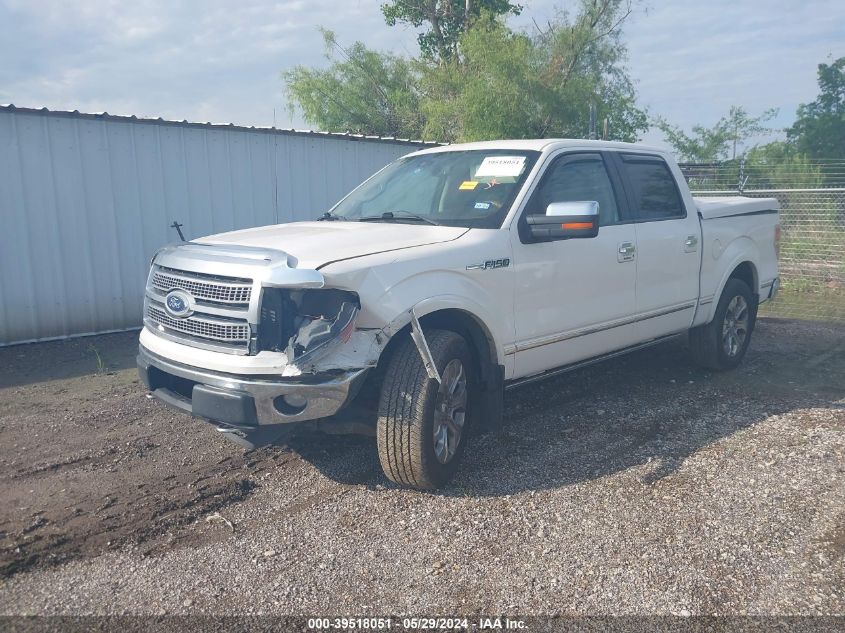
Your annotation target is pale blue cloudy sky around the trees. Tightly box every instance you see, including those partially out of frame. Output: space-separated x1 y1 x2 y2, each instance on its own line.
0 0 845 152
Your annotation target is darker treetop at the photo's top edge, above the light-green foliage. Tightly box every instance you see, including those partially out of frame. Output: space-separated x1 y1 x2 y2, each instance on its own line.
381 0 522 63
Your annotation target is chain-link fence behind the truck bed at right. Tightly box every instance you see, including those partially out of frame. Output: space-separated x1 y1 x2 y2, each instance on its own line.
681 161 845 323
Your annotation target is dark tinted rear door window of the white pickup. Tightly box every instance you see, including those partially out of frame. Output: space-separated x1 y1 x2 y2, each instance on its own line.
622 156 686 220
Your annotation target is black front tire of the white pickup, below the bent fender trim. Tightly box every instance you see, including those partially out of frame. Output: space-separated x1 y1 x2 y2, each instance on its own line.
376 330 475 490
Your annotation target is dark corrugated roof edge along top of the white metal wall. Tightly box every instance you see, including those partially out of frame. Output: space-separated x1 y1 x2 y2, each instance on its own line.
0 103 447 147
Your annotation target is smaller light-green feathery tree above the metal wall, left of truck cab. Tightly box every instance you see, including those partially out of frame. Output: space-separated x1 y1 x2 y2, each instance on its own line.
282 29 423 138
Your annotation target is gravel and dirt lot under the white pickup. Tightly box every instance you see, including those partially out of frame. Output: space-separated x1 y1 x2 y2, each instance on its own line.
0 320 845 615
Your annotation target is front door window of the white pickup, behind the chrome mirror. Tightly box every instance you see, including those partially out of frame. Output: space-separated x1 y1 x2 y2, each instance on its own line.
526 155 619 226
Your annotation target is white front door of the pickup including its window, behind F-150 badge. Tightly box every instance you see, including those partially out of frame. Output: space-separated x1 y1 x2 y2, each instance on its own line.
511 152 637 378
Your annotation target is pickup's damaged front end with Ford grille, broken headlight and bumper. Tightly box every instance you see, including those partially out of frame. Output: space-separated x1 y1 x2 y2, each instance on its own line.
138 243 380 446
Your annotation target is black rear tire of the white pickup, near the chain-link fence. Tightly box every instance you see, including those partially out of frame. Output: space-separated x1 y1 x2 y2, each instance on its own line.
689 278 757 371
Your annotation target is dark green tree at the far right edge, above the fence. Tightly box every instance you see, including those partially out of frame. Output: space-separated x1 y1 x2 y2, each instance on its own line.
787 57 845 159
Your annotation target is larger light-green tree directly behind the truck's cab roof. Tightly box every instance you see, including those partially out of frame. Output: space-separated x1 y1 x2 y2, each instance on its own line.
421 0 648 141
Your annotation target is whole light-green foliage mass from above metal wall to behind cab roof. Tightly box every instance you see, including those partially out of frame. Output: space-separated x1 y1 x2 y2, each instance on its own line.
284 0 648 141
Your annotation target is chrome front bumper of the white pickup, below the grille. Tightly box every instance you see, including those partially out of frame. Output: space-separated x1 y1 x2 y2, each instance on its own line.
137 345 367 429
